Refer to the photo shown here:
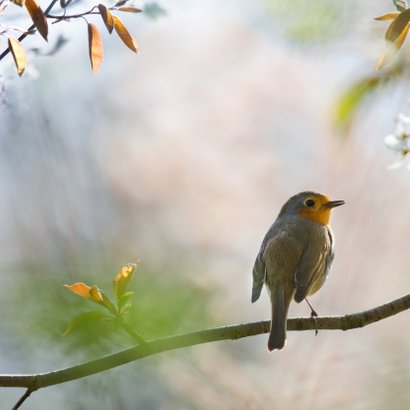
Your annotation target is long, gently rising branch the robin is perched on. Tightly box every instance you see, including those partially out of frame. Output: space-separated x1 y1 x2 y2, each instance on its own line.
0 294 410 392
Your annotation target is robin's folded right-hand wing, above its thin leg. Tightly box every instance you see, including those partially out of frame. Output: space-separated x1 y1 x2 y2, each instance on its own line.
295 231 333 303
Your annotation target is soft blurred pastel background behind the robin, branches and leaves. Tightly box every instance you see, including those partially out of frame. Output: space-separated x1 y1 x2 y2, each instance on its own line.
0 0 410 410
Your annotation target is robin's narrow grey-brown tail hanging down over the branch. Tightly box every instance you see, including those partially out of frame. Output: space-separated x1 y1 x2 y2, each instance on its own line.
268 289 292 352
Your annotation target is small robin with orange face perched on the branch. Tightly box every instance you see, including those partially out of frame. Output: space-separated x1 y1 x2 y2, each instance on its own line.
251 191 345 352
